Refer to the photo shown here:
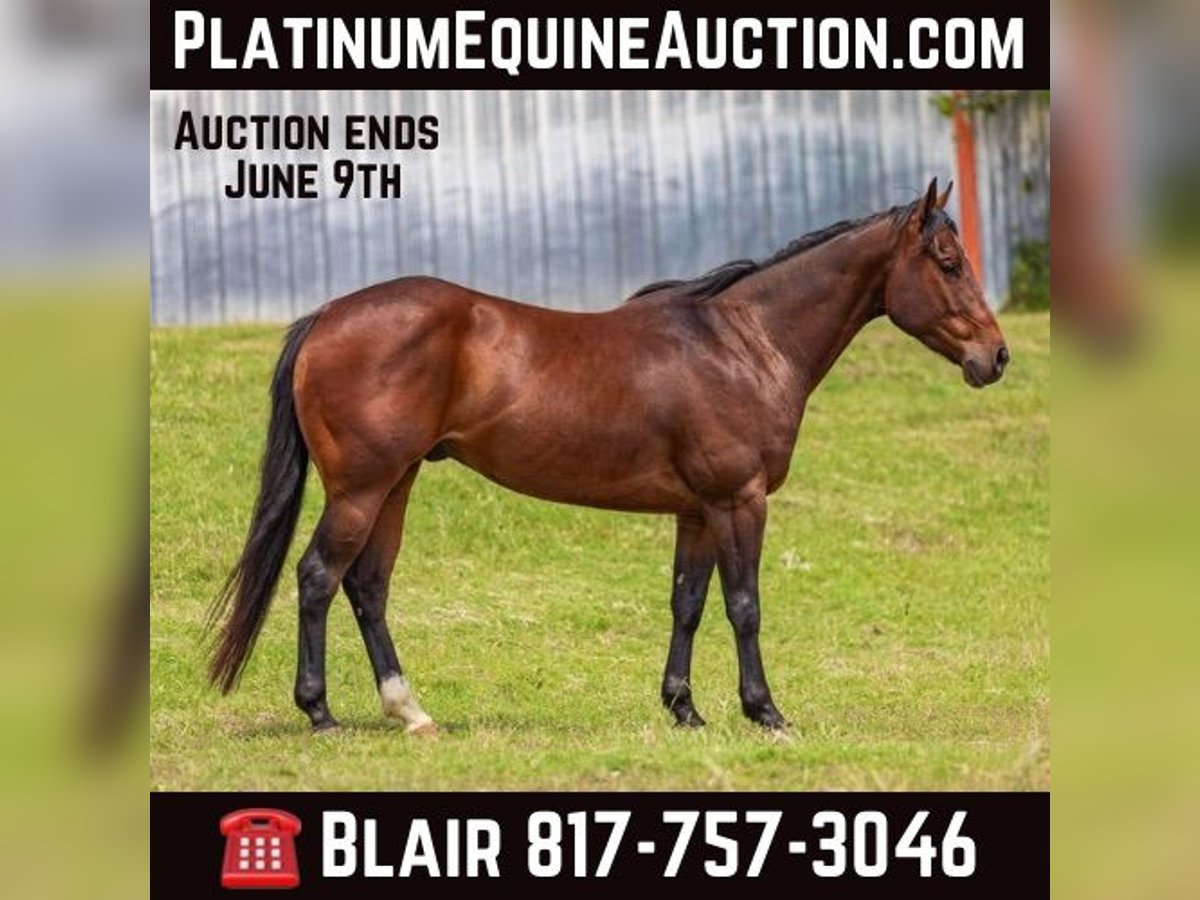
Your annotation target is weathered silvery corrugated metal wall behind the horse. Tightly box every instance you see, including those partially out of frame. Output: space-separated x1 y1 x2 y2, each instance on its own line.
150 91 1050 324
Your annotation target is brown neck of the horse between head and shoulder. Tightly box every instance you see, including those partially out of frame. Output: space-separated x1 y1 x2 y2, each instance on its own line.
715 223 894 392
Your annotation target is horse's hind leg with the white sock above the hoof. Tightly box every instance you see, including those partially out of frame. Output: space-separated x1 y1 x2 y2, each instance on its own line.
343 463 436 733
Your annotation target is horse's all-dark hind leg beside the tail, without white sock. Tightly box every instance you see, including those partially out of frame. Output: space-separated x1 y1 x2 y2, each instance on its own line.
295 488 386 731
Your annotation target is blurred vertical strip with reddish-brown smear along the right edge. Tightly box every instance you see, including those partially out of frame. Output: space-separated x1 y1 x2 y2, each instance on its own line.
1051 0 1200 898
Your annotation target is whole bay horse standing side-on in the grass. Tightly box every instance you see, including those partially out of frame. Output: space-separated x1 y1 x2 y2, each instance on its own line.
209 179 1009 733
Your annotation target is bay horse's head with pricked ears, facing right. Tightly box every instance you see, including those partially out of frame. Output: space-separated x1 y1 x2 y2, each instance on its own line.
883 179 1008 388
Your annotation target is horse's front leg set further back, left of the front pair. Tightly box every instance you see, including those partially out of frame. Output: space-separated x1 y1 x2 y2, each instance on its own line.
662 514 715 728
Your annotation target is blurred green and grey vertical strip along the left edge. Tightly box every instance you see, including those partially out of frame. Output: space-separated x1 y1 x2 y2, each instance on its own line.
0 0 149 900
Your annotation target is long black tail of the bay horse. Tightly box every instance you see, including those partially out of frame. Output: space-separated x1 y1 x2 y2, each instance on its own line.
208 313 318 694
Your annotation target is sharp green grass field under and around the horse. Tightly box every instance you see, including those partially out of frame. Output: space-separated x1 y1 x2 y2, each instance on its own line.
150 314 1050 790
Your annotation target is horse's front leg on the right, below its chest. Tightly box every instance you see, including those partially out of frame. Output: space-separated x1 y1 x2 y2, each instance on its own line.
706 482 787 728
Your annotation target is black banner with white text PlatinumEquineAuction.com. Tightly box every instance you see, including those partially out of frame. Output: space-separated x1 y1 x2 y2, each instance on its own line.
150 0 1050 90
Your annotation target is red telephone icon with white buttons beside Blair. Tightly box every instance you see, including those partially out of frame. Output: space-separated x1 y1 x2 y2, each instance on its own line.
221 809 300 888
